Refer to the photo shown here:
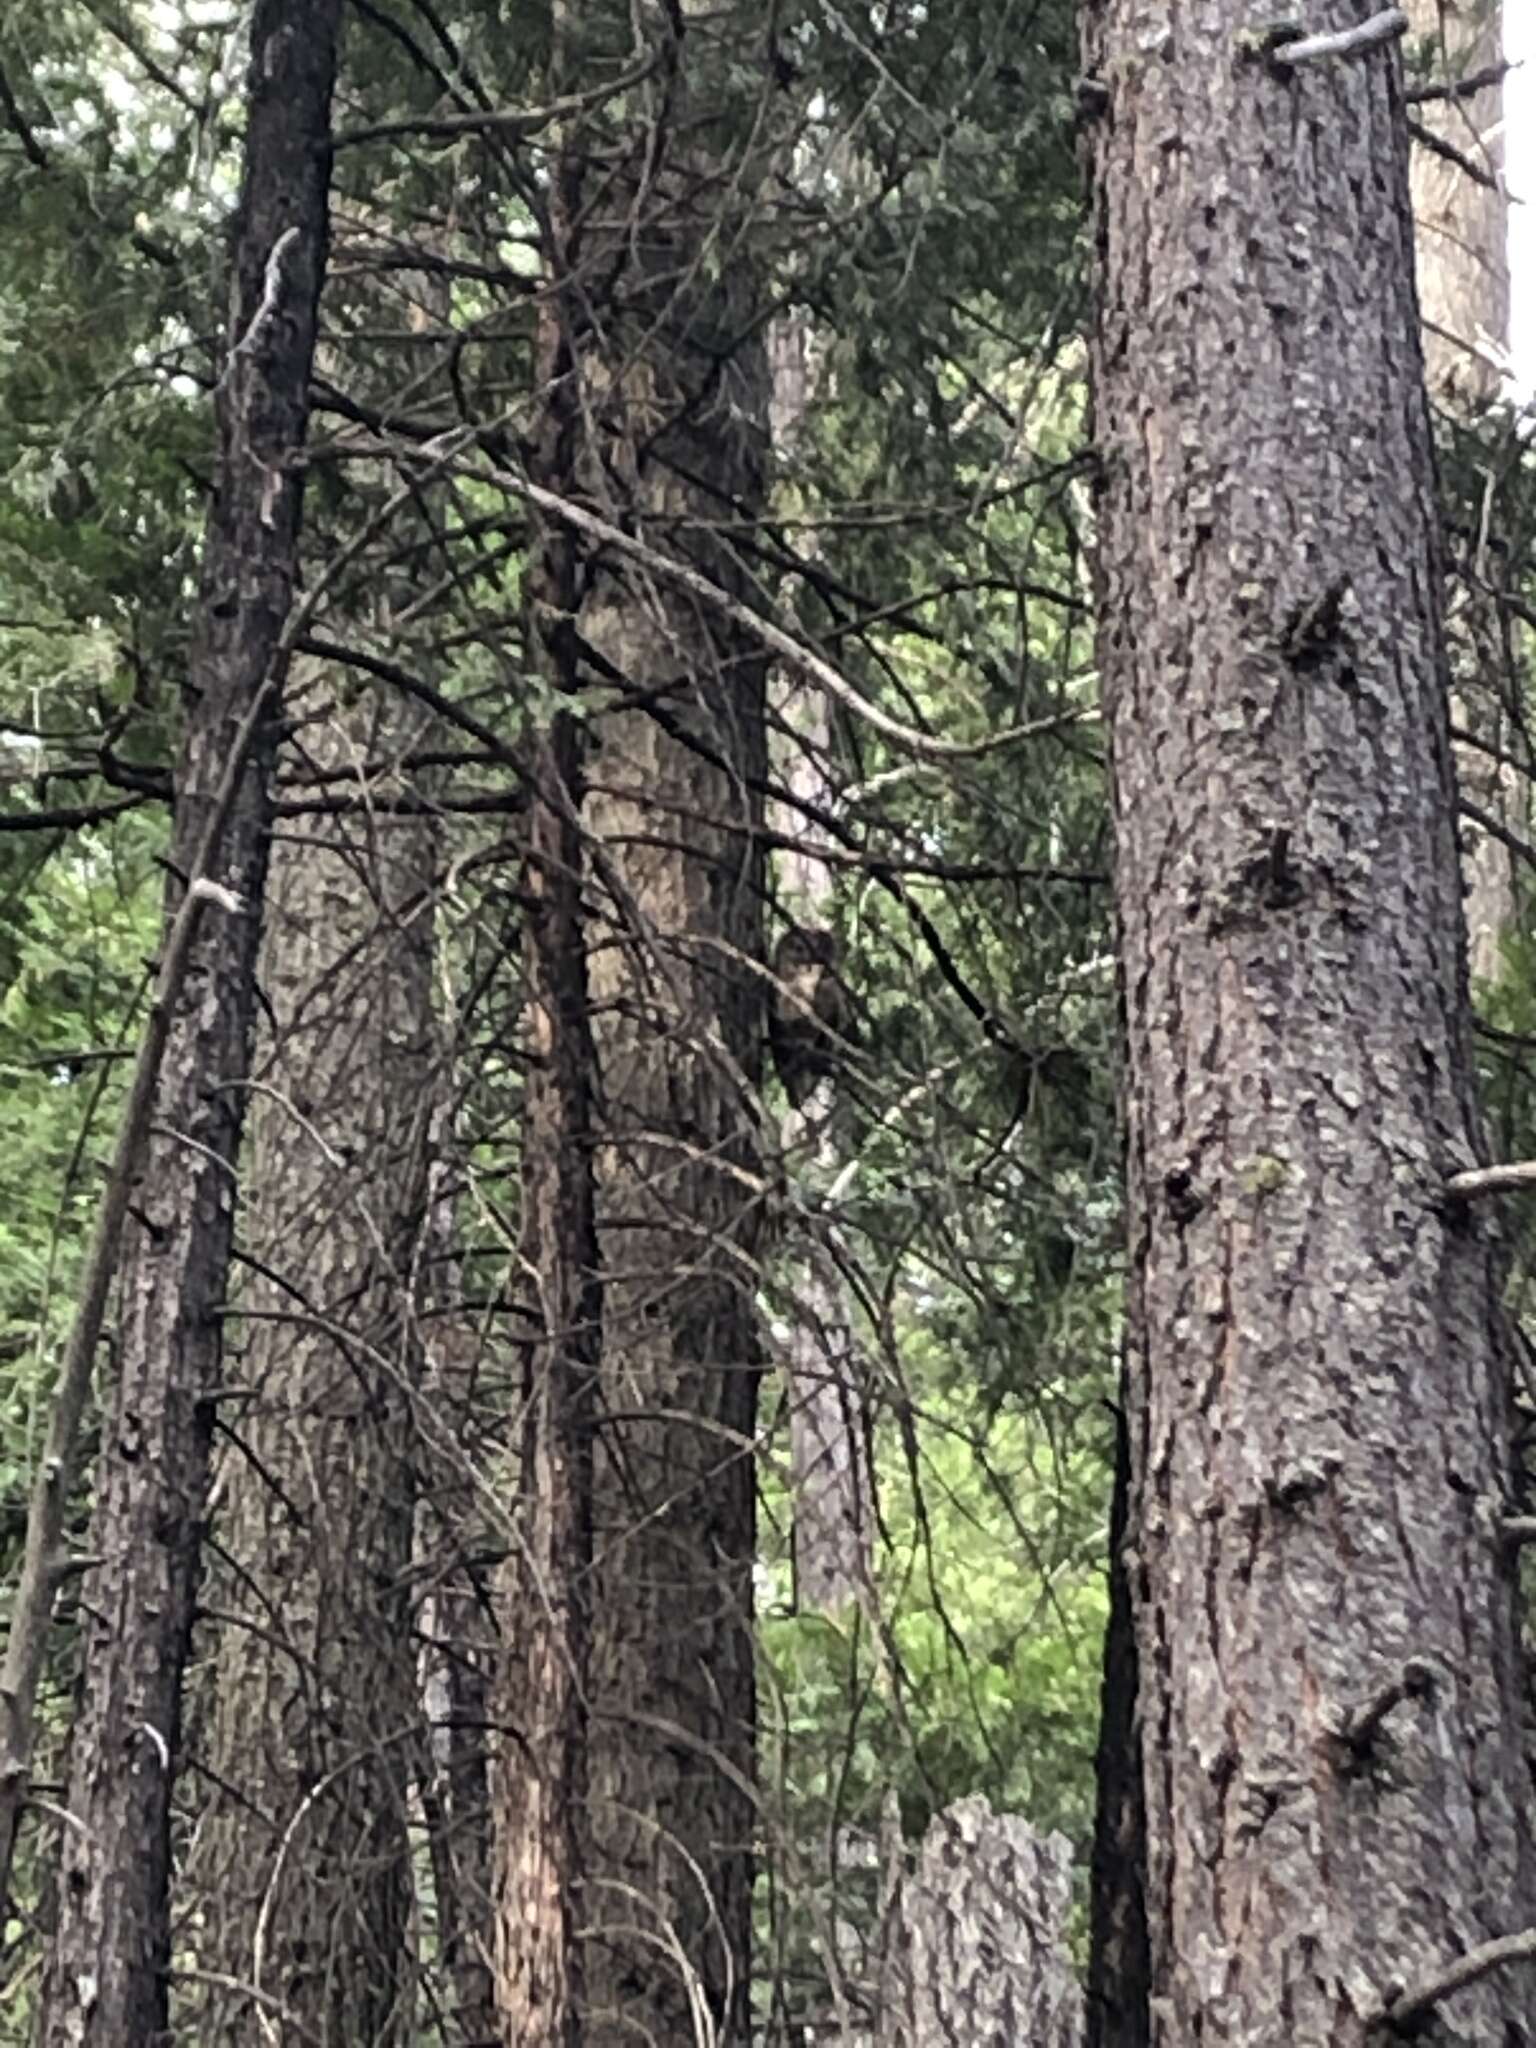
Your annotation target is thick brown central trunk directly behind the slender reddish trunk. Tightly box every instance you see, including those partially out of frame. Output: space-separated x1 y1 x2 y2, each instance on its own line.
500 8 766 2048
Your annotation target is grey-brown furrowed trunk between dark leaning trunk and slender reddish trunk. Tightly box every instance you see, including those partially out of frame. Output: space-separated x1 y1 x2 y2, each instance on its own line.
184 678 438 2048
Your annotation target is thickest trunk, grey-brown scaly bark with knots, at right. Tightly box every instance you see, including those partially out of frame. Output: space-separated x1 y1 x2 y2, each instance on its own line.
1085 0 1534 2048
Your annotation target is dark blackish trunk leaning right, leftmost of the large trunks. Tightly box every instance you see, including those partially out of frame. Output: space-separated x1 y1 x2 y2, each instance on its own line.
41 0 340 2048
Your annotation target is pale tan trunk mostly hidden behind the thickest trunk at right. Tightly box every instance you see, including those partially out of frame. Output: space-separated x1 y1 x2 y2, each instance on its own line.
1407 0 1528 983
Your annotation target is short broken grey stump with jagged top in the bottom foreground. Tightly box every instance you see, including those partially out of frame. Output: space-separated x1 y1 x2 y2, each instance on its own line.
879 1798 1083 2048
